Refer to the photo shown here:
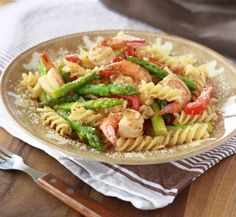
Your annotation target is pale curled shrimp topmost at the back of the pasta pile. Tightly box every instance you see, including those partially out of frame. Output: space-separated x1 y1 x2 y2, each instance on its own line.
88 33 146 66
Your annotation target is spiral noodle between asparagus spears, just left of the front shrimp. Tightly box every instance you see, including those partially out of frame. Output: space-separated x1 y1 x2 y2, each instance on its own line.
69 106 104 127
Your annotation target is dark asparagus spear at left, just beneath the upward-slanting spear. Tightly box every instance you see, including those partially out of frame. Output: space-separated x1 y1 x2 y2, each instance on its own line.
40 94 81 106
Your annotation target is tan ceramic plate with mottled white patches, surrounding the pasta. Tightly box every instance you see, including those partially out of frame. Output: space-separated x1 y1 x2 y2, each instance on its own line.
0 30 236 165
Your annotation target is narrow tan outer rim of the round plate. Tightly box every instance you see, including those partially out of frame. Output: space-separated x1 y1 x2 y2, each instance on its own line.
0 29 236 165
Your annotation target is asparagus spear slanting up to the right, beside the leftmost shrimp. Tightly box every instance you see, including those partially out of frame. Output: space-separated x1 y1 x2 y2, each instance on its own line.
51 71 99 98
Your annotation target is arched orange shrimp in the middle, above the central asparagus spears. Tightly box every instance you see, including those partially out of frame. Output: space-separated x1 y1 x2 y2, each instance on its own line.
99 60 152 84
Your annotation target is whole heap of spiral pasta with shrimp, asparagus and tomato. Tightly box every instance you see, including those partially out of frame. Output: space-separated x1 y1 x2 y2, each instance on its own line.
20 32 219 152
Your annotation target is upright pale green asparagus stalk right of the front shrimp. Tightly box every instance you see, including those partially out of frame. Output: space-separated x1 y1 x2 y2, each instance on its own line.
151 102 167 136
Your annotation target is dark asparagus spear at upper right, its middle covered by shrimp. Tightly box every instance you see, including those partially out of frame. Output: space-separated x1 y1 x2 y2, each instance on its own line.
127 56 197 90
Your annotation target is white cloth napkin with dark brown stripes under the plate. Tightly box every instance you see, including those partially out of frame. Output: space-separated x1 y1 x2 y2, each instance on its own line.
0 0 236 210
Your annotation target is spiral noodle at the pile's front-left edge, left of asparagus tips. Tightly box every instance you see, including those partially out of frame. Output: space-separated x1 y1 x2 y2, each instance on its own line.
37 106 72 136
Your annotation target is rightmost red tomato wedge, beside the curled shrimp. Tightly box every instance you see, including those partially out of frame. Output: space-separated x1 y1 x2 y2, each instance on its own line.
184 84 213 115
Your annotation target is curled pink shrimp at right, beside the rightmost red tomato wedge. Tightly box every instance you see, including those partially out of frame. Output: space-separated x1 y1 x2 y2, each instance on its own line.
160 74 191 114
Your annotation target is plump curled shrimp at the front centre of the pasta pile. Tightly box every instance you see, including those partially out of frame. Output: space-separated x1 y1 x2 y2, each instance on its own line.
100 109 144 145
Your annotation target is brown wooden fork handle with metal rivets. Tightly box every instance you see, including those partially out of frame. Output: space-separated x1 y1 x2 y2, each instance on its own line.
36 173 117 217
